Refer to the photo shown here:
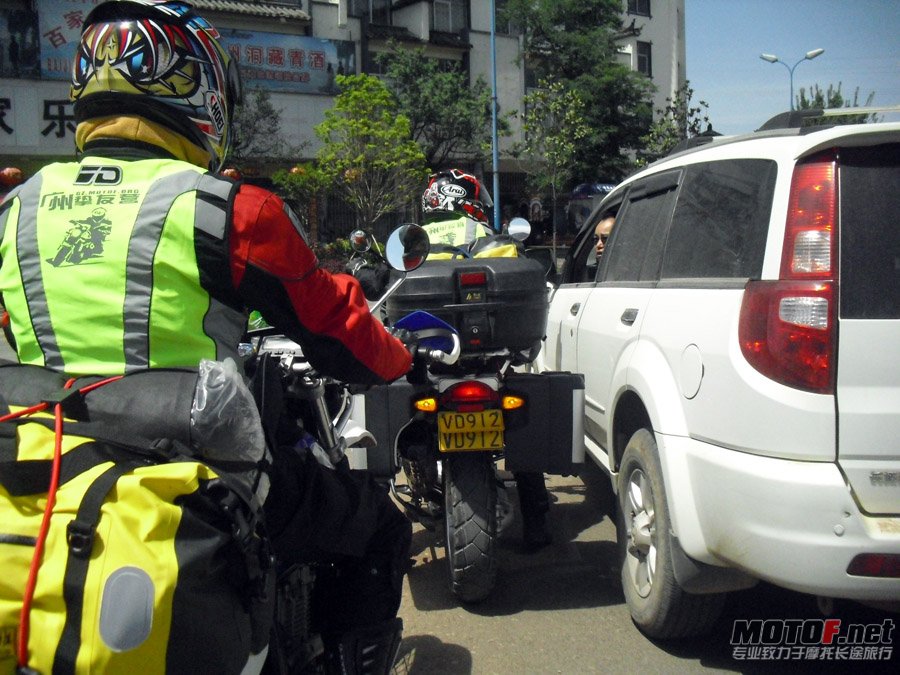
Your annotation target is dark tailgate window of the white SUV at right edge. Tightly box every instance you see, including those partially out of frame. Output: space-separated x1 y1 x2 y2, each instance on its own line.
840 143 900 319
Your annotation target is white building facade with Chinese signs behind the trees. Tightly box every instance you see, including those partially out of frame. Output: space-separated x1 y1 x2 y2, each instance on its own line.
0 0 685 190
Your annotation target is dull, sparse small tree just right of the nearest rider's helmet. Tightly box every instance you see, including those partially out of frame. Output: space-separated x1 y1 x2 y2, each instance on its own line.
229 89 303 167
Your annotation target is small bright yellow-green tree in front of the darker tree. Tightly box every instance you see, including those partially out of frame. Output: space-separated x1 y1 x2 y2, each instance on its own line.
315 75 428 234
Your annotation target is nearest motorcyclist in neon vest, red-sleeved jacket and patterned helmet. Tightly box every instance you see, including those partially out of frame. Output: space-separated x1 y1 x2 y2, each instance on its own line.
0 0 411 672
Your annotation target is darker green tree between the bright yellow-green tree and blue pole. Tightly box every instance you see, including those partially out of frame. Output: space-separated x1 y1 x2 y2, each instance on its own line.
377 42 500 169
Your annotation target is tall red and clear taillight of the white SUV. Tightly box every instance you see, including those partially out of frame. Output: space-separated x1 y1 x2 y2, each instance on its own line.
738 153 837 394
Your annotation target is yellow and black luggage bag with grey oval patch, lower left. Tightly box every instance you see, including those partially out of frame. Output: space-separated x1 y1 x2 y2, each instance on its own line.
0 366 273 675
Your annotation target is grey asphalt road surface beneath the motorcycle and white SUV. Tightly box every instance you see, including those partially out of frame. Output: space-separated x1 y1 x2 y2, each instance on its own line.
395 464 900 675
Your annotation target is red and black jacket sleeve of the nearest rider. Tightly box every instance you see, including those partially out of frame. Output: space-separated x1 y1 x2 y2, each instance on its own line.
229 185 411 384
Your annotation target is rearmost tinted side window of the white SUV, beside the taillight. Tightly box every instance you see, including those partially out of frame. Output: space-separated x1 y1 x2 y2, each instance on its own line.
660 159 777 279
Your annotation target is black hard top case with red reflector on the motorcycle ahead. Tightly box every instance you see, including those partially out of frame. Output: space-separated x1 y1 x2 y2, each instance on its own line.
385 258 549 354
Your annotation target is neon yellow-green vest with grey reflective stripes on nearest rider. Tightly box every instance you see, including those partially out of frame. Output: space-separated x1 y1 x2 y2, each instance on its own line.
0 158 245 374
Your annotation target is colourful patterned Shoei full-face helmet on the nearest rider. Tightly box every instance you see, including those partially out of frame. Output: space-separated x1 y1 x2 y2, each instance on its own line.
70 0 241 170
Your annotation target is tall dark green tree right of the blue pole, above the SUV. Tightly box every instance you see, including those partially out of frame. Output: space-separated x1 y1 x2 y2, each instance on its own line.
504 0 653 180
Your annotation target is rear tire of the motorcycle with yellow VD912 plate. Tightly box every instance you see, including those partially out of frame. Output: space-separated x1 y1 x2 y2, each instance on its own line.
443 453 497 603
